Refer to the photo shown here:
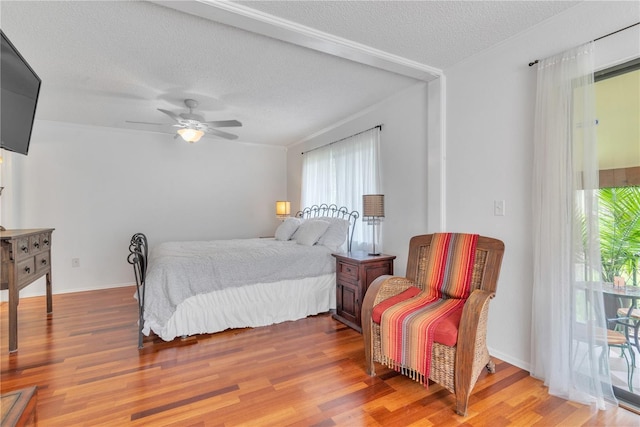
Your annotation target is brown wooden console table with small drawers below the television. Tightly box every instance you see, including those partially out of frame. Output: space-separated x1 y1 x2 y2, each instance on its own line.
0 228 54 353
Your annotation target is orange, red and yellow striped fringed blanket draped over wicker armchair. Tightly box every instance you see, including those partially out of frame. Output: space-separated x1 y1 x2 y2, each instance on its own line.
380 233 478 386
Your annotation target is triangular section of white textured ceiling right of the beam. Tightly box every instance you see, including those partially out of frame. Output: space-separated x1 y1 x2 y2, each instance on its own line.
238 0 579 69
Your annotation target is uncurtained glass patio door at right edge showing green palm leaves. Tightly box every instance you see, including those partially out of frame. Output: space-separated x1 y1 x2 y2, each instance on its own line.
595 59 640 406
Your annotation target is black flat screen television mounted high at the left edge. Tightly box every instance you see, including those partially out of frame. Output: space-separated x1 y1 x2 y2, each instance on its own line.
0 30 42 156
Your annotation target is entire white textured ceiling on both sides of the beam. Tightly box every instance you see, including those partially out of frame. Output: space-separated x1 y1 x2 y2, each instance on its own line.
0 1 575 146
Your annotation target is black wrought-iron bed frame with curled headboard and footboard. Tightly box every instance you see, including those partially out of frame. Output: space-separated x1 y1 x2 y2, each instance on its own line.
127 203 360 349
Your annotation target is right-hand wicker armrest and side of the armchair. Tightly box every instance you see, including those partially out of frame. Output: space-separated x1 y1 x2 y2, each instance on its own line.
455 289 495 394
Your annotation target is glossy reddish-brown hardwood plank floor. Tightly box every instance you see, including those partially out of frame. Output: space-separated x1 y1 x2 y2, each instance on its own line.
0 287 640 426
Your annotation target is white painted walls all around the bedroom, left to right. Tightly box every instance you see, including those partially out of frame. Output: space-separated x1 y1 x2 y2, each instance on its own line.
1 2 640 369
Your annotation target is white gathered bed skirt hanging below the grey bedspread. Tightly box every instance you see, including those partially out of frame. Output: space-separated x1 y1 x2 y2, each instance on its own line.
143 273 336 341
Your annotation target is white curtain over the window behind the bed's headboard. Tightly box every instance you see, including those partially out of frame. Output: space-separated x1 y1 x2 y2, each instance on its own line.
301 127 382 250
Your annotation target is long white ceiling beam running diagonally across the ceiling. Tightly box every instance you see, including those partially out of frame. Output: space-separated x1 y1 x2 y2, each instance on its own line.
152 0 442 82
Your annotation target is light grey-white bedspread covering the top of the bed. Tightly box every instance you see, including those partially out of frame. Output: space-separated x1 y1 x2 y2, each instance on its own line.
144 239 335 334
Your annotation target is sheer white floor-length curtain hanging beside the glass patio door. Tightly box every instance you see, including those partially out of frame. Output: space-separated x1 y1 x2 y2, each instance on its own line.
531 43 616 409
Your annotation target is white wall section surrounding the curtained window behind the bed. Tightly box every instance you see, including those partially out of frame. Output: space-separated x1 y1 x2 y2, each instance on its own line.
287 83 428 274
